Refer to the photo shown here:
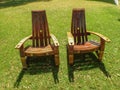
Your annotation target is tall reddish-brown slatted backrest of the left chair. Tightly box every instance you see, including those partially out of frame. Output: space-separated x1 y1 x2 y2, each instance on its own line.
32 10 50 47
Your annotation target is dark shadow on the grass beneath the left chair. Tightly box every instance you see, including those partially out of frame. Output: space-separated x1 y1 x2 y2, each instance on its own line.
14 56 59 88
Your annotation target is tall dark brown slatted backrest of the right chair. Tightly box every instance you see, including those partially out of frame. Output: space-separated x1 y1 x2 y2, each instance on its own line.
71 9 88 45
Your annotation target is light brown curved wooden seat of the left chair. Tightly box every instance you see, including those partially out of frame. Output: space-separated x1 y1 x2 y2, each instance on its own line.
25 45 54 56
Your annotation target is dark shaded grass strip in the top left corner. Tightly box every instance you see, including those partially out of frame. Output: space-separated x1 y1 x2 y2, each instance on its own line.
0 0 51 9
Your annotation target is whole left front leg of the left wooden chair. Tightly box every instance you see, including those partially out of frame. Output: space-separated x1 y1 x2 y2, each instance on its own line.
20 45 27 69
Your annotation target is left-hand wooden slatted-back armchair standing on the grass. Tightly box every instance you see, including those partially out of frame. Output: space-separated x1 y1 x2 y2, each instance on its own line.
15 10 59 68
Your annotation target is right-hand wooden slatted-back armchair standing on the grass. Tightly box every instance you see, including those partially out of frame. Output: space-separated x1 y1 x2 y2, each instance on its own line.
67 9 110 65
